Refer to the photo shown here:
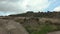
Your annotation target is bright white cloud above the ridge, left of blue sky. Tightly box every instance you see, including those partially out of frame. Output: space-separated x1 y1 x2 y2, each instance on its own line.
22 0 50 11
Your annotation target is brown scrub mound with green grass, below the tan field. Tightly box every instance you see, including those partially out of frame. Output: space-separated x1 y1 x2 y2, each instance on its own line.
14 18 60 34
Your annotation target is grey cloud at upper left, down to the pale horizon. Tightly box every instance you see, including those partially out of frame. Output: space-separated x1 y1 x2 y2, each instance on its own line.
0 0 22 16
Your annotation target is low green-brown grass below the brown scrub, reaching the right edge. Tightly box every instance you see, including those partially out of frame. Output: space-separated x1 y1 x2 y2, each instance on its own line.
17 20 60 34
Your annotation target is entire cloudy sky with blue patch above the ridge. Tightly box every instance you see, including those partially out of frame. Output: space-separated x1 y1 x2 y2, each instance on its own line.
0 0 60 16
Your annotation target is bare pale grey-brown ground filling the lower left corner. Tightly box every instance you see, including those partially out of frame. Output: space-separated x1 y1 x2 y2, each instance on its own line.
0 19 28 34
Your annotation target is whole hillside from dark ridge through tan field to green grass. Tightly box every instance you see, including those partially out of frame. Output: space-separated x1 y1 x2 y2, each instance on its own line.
0 12 60 34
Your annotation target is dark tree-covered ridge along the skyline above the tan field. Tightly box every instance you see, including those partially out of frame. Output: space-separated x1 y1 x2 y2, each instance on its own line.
9 11 60 18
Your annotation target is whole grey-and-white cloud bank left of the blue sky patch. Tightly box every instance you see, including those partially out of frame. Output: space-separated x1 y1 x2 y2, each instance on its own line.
0 0 50 14
